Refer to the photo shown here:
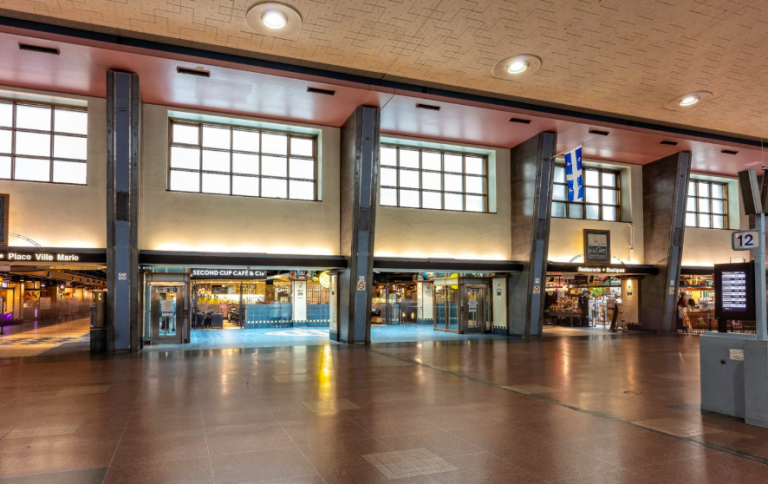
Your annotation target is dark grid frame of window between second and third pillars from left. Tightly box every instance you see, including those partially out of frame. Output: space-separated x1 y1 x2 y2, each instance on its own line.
377 143 491 214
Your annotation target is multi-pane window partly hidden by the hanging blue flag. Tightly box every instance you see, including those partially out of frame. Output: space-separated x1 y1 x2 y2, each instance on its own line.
552 165 621 222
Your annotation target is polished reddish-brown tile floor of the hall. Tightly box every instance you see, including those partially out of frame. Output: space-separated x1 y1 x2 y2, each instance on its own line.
0 333 768 484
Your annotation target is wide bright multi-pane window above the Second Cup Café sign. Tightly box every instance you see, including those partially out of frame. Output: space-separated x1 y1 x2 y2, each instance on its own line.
168 120 317 200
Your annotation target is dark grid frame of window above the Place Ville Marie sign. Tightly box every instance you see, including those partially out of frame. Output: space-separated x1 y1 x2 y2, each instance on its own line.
0 98 88 187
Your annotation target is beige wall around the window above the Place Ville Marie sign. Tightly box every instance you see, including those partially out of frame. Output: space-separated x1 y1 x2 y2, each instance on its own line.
0 87 107 248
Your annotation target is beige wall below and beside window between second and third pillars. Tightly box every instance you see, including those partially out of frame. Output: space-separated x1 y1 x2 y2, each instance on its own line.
374 142 512 260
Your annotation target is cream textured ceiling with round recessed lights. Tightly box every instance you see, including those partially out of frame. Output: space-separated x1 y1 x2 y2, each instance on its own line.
0 0 768 137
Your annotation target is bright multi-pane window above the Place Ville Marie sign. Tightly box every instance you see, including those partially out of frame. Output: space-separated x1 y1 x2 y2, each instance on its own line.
0 99 88 185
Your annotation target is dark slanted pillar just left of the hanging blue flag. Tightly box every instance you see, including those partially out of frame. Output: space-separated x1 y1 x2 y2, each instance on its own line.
509 133 557 336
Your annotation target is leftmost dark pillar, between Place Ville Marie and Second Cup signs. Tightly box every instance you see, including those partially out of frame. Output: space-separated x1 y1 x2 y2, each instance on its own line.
107 70 141 351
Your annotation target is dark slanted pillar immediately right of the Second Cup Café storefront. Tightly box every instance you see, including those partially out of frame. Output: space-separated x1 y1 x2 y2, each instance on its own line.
340 106 379 344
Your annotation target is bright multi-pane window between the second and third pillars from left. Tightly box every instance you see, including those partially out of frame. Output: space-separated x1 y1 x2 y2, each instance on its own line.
379 145 488 212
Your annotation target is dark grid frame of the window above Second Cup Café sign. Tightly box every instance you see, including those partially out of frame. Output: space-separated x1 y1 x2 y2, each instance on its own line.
165 117 320 202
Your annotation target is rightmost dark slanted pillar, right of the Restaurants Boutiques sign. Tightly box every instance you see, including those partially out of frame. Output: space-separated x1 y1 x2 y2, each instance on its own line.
640 152 691 332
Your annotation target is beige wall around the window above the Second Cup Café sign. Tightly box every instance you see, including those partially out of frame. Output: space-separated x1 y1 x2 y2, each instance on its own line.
141 104 340 255
